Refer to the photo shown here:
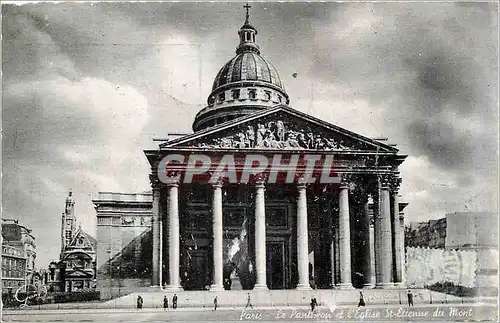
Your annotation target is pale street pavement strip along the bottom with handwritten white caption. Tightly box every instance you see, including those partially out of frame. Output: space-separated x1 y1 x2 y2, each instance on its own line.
2 303 498 323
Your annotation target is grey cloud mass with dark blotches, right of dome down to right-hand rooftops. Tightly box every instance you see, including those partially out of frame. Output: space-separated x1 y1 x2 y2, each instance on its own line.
306 3 498 216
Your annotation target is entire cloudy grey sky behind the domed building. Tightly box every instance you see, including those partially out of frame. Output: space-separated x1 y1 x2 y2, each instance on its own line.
2 2 499 268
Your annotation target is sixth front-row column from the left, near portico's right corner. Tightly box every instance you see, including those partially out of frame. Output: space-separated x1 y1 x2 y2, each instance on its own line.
377 184 393 288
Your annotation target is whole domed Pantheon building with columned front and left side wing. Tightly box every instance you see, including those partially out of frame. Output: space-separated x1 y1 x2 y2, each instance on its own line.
93 8 406 296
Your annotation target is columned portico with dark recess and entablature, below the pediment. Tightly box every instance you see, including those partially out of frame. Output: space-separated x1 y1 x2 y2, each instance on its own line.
146 128 404 291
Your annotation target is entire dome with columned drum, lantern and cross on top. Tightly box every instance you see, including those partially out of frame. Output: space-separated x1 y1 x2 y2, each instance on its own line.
193 5 289 131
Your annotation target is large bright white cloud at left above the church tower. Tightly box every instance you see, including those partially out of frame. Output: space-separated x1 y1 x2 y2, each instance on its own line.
3 5 149 265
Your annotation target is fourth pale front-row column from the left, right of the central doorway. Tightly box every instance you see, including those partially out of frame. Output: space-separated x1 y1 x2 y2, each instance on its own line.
297 183 311 290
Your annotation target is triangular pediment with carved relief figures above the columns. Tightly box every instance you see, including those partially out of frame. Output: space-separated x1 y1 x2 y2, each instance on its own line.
160 106 398 153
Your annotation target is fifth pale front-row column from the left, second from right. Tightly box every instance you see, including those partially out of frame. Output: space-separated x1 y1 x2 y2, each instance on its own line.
339 183 352 289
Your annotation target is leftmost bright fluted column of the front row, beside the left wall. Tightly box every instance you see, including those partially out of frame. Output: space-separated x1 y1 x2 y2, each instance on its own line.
167 182 180 291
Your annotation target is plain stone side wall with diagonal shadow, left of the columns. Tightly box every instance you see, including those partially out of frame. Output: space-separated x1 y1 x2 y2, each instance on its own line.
93 192 152 298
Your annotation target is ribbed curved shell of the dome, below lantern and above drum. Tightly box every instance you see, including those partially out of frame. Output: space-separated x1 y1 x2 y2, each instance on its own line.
212 52 285 91
